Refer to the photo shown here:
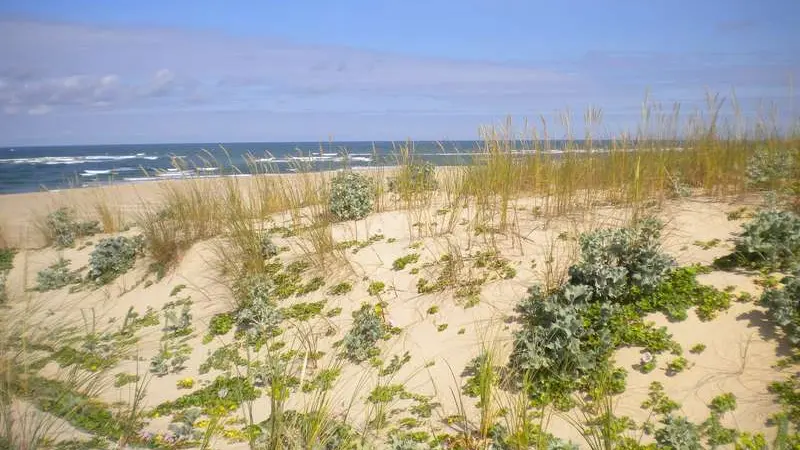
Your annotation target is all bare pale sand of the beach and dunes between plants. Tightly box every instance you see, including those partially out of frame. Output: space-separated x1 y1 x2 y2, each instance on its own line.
0 164 786 449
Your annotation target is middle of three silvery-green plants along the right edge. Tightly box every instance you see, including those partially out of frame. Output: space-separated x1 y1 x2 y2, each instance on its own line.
735 209 800 269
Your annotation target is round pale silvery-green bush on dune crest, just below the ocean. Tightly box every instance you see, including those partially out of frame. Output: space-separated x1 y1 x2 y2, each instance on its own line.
329 171 375 221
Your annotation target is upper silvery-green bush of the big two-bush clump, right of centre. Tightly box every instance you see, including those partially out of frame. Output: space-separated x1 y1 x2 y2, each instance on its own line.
569 218 675 301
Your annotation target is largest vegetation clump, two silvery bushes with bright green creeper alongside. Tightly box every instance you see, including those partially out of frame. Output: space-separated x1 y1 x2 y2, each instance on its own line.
509 219 693 401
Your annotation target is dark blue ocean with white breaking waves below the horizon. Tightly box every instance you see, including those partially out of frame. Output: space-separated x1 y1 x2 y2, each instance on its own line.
0 141 602 194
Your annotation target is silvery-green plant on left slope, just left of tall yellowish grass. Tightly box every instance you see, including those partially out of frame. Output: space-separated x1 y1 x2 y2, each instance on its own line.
88 236 144 283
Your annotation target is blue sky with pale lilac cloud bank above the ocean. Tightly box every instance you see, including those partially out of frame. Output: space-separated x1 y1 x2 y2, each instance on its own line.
0 0 800 146
